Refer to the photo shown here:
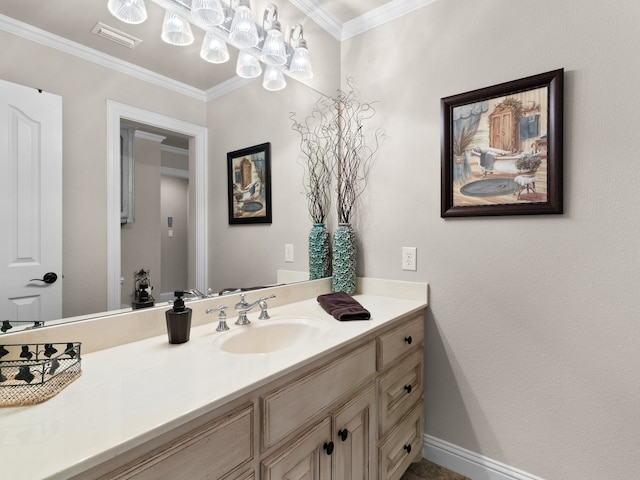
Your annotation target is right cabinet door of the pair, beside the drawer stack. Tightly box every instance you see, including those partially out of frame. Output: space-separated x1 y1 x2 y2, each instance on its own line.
332 385 378 480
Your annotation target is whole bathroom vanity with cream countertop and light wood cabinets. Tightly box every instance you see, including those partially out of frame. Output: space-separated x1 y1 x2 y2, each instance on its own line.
0 280 427 480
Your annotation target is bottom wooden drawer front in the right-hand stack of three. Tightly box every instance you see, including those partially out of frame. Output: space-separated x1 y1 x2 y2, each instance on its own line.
378 402 423 480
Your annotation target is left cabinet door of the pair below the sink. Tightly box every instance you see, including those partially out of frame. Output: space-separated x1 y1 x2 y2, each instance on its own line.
260 417 334 480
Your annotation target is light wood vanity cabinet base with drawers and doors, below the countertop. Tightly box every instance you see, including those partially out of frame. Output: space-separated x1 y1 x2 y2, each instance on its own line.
97 313 424 480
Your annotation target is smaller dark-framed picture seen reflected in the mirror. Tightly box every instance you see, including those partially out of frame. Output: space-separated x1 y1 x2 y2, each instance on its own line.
227 143 271 224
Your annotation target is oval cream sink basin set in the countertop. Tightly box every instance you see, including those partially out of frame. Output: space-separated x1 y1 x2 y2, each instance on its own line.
216 318 328 354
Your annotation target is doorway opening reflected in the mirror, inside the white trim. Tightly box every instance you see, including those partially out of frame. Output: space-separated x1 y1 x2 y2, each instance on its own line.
120 121 190 308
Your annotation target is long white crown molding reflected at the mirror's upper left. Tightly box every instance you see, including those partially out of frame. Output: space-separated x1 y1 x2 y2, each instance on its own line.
0 14 205 101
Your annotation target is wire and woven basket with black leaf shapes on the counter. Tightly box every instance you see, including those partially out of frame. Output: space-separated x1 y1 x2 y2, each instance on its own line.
0 342 82 407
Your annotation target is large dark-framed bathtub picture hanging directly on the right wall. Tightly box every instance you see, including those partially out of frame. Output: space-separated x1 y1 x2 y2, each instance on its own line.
440 69 564 217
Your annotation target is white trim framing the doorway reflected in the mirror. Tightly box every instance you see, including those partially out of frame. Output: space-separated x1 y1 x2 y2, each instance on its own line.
107 100 209 310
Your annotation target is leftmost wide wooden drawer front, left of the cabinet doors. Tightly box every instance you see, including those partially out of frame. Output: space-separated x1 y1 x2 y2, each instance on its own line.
109 405 253 480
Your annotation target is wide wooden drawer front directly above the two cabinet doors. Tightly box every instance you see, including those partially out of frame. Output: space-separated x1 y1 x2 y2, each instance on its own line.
262 342 376 448
